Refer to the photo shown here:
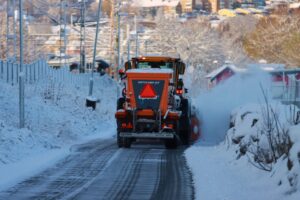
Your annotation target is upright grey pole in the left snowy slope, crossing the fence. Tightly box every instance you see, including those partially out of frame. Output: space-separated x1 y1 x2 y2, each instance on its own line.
19 0 25 128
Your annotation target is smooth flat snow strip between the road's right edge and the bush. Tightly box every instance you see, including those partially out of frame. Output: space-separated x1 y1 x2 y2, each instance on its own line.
185 145 300 200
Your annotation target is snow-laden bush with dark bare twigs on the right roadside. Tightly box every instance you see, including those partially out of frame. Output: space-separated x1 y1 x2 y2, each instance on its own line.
226 102 300 193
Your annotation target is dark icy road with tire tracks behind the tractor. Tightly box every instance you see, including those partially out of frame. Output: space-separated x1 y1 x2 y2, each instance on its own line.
0 139 194 200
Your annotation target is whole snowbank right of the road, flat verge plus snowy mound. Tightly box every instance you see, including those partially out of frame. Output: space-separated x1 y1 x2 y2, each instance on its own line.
185 103 300 200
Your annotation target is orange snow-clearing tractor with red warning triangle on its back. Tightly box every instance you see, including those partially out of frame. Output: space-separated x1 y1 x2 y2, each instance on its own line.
115 56 200 148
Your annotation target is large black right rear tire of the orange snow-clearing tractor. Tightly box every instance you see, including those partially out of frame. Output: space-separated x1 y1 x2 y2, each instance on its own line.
179 99 191 145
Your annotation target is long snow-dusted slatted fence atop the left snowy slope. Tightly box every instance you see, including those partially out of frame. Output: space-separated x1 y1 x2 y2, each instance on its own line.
0 59 90 86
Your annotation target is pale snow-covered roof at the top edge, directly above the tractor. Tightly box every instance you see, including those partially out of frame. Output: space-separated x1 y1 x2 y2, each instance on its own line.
133 0 179 7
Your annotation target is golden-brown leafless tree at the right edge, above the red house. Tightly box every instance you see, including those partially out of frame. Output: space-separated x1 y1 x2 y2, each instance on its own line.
244 15 300 66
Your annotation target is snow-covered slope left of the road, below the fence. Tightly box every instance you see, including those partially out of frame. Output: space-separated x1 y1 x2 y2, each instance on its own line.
0 74 117 190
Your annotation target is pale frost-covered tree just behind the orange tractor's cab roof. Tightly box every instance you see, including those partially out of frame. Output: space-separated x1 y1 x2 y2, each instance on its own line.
155 18 224 71
